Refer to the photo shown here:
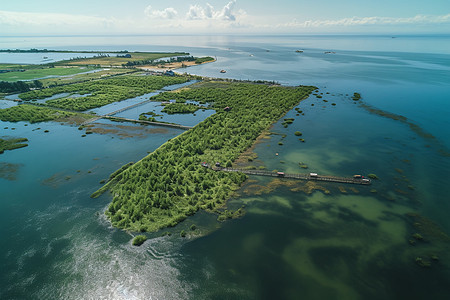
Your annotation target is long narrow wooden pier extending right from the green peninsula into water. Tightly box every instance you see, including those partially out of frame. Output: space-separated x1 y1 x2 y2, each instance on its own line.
209 164 372 185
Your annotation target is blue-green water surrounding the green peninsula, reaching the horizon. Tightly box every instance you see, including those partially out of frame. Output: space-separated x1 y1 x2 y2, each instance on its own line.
0 36 450 299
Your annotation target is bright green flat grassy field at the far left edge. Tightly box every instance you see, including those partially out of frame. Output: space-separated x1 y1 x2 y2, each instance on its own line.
0 67 93 82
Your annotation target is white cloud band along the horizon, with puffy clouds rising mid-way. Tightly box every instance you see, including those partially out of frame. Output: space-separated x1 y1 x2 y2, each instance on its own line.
0 6 450 35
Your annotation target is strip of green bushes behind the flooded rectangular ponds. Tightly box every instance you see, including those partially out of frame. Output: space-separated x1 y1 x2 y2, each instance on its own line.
19 75 190 111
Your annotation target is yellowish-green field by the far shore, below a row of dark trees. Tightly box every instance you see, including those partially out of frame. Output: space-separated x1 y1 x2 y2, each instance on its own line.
60 52 188 67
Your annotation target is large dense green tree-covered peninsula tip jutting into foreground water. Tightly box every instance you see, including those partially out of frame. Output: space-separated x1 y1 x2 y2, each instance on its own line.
93 81 316 232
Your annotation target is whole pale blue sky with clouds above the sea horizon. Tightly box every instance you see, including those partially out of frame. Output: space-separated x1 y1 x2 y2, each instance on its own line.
0 0 450 36
